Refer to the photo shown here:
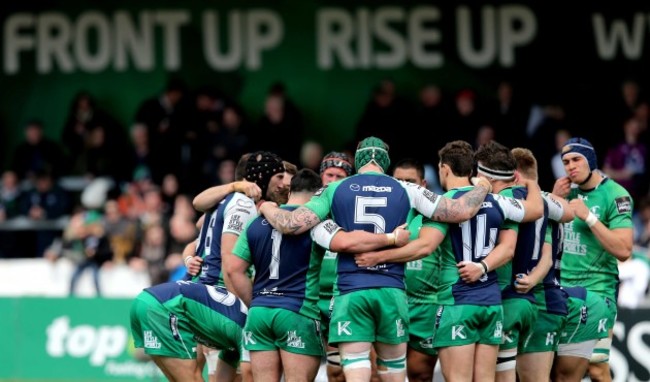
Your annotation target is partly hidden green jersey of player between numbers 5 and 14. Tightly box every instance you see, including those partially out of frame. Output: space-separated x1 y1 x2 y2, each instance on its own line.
404 214 440 304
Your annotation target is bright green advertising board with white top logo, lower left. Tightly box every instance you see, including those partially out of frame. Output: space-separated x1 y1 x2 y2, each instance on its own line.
0 298 164 382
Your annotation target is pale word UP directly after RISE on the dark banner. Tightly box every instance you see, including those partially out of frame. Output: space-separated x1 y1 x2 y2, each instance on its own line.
456 5 537 68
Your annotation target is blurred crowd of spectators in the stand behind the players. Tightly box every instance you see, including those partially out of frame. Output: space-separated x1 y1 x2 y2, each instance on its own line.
0 78 650 306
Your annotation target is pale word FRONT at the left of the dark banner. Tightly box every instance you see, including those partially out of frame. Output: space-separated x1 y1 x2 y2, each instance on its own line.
3 10 190 74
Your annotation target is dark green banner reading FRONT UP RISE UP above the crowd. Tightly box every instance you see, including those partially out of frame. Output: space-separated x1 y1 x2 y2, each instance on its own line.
0 0 650 163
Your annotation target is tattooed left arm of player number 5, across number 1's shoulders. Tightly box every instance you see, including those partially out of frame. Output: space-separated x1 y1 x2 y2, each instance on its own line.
259 202 320 235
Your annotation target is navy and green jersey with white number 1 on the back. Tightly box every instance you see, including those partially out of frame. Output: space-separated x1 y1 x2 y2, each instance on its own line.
233 206 323 320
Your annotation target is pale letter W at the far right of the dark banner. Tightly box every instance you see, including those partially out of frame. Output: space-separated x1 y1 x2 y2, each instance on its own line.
591 13 650 61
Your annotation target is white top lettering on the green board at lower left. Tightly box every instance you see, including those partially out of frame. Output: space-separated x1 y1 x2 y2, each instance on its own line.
45 316 128 366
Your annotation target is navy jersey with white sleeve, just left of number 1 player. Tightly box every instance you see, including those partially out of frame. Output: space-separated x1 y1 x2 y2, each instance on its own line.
192 192 258 286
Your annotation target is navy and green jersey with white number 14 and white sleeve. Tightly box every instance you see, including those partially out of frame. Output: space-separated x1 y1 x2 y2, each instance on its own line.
423 186 524 305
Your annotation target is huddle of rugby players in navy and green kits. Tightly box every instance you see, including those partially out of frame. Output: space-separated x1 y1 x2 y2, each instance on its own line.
130 137 633 382
